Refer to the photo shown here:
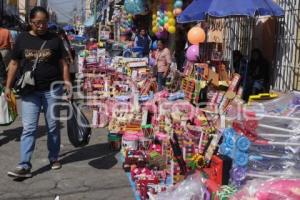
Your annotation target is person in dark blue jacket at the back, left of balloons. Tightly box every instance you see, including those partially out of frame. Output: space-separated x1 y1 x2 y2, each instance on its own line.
134 28 152 57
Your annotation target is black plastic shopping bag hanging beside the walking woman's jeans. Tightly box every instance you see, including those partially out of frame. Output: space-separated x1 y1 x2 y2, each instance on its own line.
67 102 91 147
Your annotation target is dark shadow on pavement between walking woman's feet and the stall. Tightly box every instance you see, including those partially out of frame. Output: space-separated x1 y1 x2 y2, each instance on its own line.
61 143 118 169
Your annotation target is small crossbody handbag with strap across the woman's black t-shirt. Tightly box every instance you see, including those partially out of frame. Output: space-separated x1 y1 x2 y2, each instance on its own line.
15 41 47 96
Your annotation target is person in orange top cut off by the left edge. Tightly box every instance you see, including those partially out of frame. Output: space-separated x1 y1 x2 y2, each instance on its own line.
0 21 13 67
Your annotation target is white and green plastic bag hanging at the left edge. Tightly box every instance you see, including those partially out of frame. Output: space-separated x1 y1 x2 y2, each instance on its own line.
0 86 18 126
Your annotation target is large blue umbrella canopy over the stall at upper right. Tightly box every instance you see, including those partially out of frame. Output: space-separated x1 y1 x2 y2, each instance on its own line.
177 0 284 23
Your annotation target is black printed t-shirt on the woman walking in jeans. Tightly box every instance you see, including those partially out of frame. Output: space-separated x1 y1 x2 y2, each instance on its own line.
11 32 67 91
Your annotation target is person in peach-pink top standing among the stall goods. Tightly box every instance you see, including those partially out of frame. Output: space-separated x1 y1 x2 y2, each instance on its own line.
156 40 172 91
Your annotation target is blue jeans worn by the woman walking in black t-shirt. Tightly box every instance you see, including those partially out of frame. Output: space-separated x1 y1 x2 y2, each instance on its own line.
19 85 63 169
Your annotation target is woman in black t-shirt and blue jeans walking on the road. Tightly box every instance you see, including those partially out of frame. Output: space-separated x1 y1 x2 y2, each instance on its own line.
5 7 71 178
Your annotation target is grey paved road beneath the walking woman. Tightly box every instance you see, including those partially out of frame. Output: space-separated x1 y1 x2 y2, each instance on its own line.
0 101 134 200
